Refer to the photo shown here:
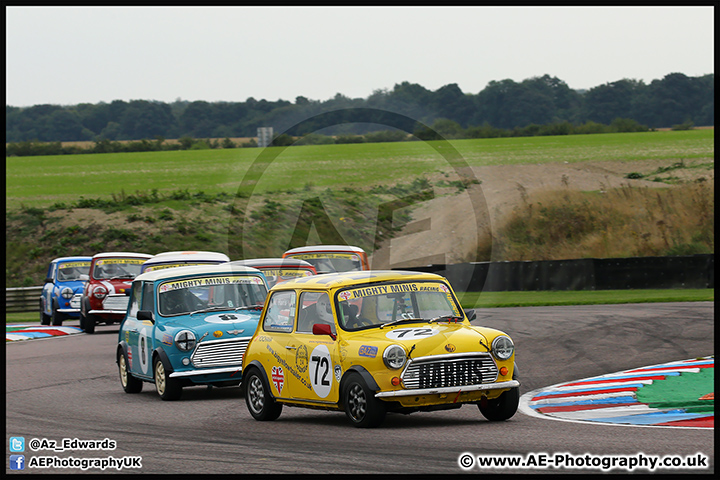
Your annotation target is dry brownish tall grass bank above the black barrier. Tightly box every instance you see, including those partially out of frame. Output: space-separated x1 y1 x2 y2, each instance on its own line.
478 178 715 260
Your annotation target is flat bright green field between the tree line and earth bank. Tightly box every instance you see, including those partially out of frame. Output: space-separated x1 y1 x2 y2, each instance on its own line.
5 130 715 208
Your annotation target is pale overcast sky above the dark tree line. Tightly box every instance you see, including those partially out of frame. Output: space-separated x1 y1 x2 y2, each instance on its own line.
5 6 714 106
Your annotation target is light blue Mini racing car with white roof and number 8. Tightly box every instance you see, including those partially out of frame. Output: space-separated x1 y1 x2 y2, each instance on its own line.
115 264 267 400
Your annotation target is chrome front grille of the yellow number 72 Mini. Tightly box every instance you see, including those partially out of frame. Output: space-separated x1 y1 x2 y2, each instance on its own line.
400 353 498 390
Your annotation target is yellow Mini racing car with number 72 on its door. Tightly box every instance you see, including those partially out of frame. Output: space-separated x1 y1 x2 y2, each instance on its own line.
243 271 520 427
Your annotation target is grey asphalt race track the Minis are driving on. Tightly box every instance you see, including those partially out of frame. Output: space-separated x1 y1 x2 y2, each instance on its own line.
6 302 715 475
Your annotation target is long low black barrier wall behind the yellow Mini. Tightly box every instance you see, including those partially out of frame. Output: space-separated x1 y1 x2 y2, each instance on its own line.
403 254 715 292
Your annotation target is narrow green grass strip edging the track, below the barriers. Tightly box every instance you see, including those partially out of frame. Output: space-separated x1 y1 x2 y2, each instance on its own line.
5 288 715 323
